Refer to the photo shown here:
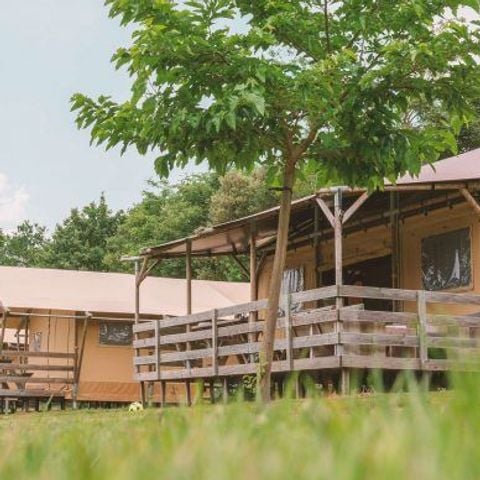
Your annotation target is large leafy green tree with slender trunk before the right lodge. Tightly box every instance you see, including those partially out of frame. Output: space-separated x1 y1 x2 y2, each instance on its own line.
72 0 480 400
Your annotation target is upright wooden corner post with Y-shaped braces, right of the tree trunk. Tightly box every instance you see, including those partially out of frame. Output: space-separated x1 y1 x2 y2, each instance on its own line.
334 187 350 394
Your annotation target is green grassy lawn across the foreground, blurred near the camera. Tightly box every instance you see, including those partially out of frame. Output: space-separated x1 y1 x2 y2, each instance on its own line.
0 376 480 480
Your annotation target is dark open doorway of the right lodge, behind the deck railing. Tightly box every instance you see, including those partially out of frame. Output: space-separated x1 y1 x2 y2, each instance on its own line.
322 255 392 311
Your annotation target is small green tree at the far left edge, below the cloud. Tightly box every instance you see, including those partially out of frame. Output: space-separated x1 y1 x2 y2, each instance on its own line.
0 220 48 267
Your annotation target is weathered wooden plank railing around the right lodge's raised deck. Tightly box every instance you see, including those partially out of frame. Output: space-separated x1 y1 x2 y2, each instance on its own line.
133 286 480 381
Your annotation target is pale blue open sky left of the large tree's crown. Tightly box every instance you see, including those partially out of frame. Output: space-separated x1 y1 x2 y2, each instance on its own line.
0 0 199 231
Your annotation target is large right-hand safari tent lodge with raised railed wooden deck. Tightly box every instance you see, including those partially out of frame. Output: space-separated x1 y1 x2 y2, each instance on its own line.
133 149 480 400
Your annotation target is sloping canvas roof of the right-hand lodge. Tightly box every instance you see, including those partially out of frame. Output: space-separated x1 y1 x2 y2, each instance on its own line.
141 148 480 258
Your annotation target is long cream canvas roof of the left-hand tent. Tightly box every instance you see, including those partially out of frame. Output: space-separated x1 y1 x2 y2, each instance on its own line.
0 267 249 316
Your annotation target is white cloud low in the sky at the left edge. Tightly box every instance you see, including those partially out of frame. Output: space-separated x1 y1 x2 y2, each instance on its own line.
0 172 30 230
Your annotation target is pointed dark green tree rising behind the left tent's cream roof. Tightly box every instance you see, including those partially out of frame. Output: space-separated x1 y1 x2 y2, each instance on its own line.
44 194 124 271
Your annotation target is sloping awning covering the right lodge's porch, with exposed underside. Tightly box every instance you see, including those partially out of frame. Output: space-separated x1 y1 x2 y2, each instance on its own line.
141 149 480 258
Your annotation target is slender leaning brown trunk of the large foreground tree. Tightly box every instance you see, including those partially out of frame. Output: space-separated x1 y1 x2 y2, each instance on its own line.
257 159 296 402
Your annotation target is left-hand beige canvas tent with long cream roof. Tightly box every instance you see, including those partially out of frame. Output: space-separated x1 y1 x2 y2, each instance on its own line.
0 267 248 402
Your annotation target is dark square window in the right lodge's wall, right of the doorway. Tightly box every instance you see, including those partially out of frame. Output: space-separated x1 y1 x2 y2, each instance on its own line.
422 228 472 290
